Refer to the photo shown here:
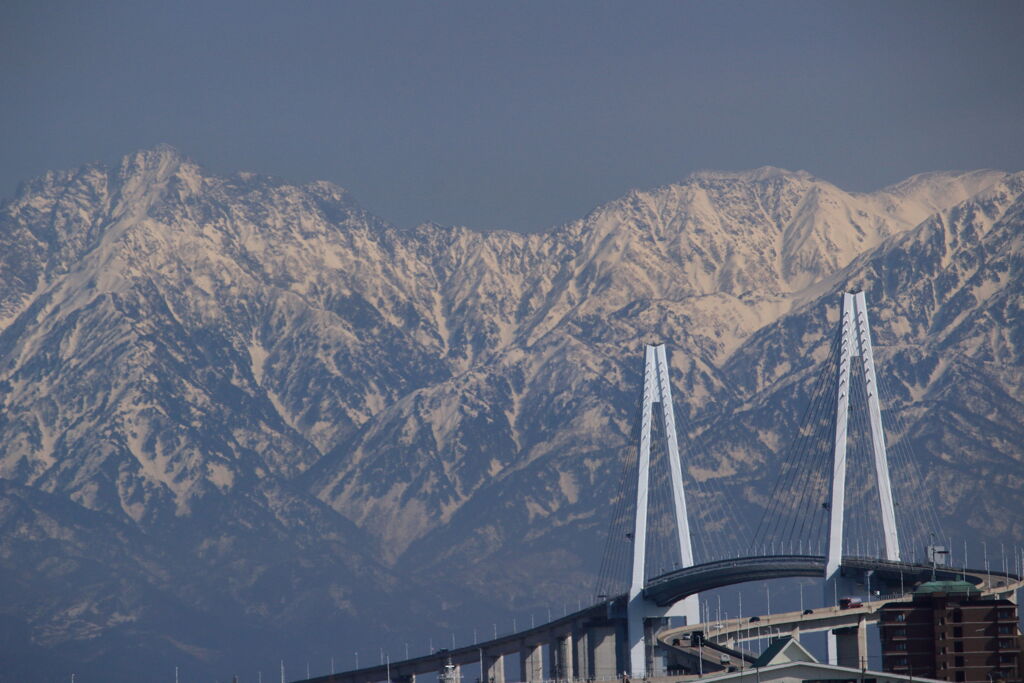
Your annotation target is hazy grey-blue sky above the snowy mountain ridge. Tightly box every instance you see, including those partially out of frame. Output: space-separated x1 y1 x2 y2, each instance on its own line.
0 0 1024 230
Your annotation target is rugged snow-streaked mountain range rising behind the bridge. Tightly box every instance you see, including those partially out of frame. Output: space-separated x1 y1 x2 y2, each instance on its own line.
0 146 1024 680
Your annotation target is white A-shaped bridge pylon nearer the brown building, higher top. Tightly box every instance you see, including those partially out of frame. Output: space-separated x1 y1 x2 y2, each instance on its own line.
825 292 899 664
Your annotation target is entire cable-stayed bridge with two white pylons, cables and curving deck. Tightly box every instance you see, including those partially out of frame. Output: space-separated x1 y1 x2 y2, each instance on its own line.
299 292 1022 683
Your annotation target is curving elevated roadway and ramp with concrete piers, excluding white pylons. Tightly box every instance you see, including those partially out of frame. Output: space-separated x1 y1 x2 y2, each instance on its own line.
299 555 1024 683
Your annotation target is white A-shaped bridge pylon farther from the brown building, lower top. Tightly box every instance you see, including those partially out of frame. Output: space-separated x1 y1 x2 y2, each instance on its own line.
627 344 699 678
